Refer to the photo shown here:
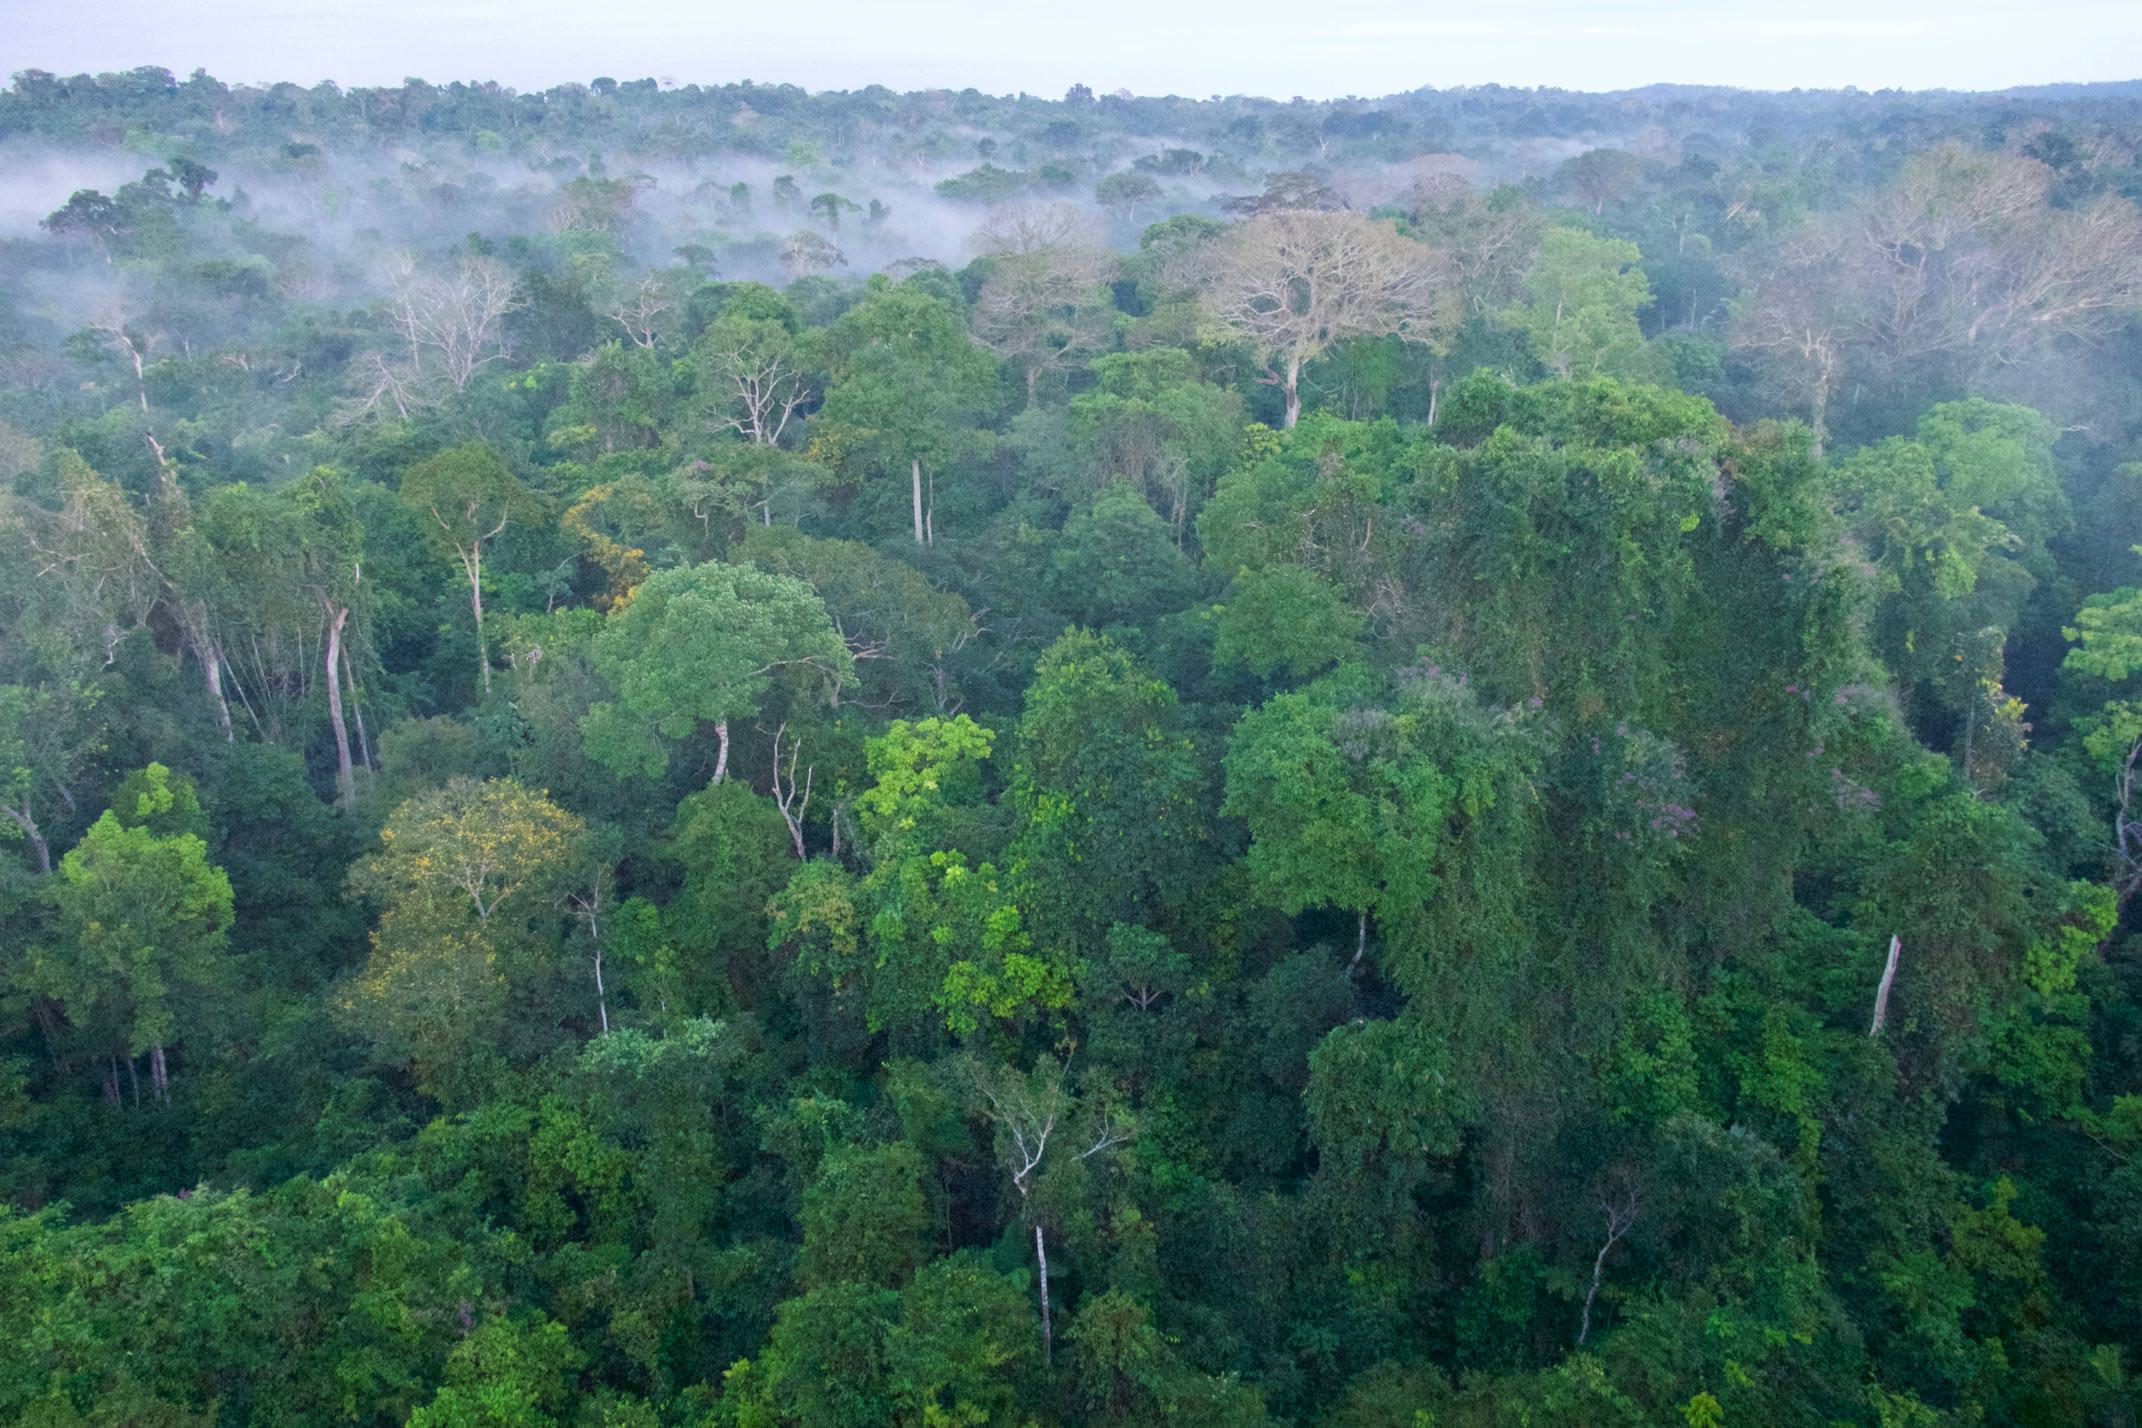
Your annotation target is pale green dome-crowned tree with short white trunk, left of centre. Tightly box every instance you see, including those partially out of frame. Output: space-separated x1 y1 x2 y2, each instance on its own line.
580 561 855 784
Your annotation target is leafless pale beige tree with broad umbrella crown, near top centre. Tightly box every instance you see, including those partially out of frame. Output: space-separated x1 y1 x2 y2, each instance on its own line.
1206 208 1457 428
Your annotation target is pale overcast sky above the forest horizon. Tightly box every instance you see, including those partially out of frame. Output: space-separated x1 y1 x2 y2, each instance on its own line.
0 0 2142 98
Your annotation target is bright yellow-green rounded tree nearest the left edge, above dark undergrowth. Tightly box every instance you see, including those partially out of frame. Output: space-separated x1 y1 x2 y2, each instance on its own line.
30 764 231 1100
